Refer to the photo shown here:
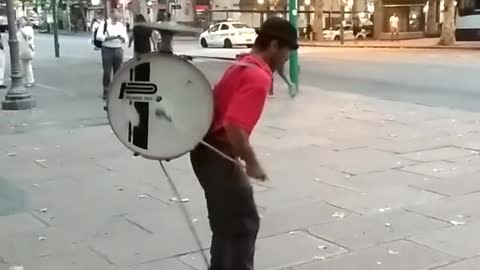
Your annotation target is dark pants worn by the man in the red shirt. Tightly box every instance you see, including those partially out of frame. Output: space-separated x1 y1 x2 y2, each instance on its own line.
190 141 260 270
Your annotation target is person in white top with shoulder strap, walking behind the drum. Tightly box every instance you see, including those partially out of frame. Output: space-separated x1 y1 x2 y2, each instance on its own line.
93 9 128 99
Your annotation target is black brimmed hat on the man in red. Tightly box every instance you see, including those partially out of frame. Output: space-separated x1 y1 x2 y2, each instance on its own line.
257 17 298 50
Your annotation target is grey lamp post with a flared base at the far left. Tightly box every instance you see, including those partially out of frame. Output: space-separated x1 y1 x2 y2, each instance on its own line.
2 0 36 110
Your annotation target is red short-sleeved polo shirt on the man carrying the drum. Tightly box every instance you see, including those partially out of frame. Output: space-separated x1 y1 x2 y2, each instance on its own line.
209 55 272 139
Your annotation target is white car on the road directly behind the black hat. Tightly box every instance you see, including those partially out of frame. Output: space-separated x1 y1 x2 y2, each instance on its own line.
200 22 257 48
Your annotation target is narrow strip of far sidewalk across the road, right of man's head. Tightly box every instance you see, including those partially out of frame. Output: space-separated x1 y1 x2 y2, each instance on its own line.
300 38 480 50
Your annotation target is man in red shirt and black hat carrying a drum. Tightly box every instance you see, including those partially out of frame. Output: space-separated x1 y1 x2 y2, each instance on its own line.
190 17 298 270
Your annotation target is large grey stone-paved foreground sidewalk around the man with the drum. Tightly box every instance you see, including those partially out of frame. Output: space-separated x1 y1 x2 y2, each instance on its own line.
0 58 480 270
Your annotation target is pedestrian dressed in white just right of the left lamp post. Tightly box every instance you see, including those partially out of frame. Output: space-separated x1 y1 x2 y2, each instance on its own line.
17 17 35 88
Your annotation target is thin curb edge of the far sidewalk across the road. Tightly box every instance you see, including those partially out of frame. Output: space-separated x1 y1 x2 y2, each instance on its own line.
300 43 480 51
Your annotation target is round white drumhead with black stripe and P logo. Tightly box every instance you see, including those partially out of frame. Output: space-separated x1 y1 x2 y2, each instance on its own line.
107 53 213 160
